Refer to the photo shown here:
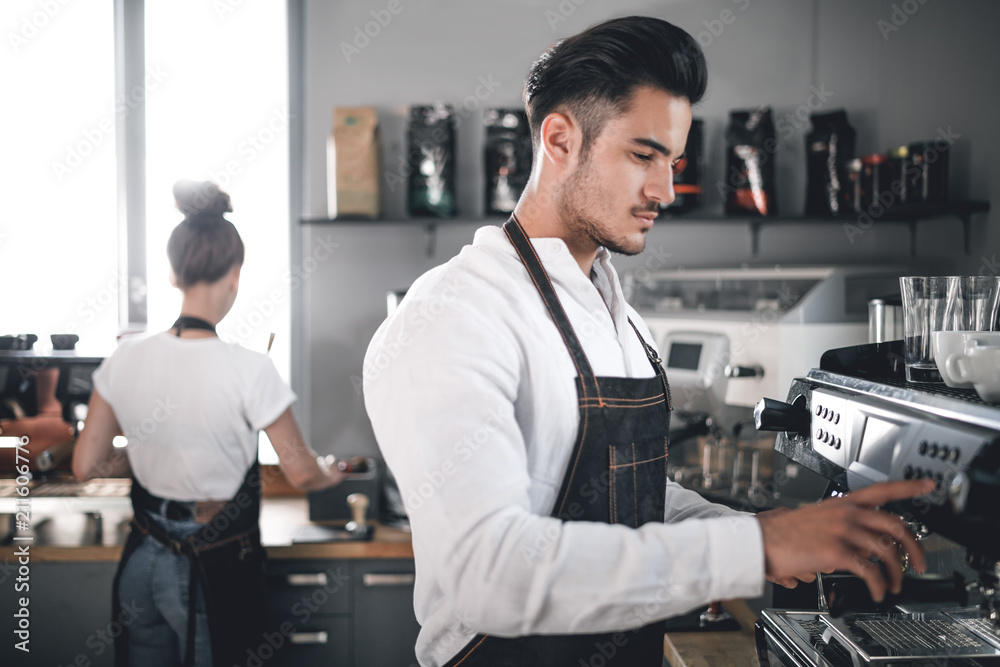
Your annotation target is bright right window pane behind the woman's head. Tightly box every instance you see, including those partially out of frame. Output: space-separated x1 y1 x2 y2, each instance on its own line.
145 0 291 463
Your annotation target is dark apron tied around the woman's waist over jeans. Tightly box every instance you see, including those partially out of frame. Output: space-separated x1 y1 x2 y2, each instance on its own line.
112 461 267 667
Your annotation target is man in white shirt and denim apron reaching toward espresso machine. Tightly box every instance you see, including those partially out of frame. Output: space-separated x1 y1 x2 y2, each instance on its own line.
364 17 932 667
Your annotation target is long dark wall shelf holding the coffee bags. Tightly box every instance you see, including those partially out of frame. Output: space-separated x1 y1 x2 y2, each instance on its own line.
300 201 990 258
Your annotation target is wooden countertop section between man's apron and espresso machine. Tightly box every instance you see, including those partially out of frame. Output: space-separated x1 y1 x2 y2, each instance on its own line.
663 600 760 667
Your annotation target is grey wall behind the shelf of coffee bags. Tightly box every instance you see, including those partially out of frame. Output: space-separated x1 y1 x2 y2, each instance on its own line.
293 0 1000 455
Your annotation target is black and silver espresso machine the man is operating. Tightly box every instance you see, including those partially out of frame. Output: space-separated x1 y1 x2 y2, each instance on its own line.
754 341 1000 667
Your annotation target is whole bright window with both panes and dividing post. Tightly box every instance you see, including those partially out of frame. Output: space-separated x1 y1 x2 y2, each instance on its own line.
0 0 291 463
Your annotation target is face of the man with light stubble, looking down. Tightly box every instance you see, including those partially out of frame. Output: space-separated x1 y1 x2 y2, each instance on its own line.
559 87 691 255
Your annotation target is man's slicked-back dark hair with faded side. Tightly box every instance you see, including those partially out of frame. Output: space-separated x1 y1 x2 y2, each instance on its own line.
524 16 708 156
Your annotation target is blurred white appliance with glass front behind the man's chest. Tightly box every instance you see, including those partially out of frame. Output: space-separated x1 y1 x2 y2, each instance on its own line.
623 266 906 424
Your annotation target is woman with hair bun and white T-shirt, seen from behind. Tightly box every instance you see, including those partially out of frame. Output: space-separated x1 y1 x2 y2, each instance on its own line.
73 181 343 667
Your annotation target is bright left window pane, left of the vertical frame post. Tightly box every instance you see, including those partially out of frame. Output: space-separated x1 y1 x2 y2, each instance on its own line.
0 0 117 355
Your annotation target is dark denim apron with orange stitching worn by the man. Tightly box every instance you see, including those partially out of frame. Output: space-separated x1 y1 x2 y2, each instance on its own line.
446 216 673 667
